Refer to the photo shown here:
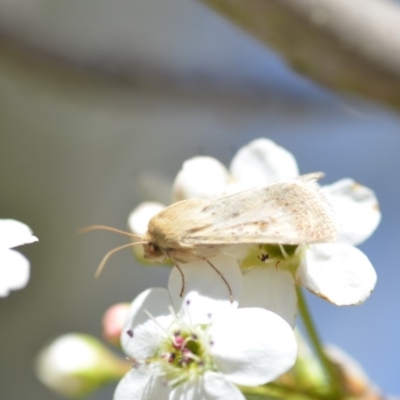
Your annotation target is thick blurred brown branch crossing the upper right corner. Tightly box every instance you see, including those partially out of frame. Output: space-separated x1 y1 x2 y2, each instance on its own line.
201 0 400 110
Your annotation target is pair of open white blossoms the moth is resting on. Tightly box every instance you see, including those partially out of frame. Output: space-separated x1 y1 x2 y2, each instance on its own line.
110 139 380 400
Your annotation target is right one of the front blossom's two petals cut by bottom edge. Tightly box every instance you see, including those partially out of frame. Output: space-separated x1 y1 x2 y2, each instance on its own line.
170 372 245 400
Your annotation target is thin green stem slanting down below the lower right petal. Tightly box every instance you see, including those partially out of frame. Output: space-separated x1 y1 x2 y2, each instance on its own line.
296 286 343 399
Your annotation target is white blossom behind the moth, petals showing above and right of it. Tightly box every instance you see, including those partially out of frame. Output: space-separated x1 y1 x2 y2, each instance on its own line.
130 139 381 326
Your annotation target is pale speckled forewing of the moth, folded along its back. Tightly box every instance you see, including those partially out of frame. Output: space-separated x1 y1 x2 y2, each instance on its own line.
182 180 337 245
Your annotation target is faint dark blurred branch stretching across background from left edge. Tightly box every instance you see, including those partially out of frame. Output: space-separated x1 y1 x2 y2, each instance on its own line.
0 32 319 111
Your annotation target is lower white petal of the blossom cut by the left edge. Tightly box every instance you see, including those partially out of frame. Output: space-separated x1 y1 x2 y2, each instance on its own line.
0 250 30 297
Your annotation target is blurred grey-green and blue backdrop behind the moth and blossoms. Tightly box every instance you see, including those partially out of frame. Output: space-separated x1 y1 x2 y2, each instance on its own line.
0 0 400 400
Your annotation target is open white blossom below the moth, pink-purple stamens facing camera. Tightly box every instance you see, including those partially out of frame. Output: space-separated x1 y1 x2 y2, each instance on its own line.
114 284 297 400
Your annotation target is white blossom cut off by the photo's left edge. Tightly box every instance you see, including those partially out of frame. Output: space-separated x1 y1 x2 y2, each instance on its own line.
0 219 38 297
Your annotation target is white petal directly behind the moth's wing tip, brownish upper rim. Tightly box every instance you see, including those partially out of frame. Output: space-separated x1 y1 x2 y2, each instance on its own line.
322 178 381 245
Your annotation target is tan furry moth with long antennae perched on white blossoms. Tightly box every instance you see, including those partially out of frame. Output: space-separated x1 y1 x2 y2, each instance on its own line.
85 173 337 298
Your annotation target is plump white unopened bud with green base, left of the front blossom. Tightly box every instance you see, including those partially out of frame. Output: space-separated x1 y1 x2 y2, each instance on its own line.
35 333 130 397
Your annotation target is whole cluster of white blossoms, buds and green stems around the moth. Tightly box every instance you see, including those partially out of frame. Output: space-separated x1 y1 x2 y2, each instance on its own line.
36 139 381 400
